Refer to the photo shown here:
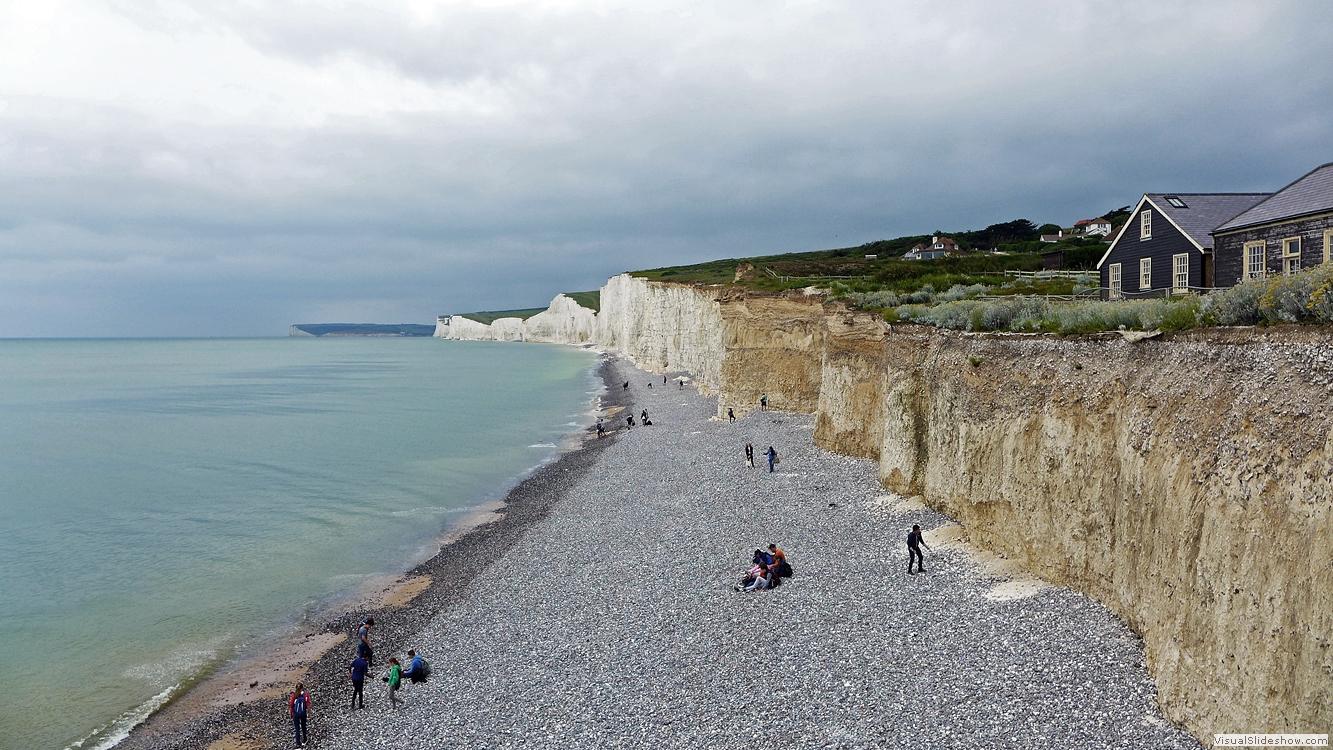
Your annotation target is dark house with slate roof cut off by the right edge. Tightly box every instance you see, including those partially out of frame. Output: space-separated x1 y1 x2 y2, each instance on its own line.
1213 163 1333 286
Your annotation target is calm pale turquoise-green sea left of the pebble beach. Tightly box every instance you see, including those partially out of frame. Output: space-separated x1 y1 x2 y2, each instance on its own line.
0 337 601 750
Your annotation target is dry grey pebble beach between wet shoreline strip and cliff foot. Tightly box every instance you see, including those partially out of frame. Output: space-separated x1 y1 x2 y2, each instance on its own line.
321 364 1198 749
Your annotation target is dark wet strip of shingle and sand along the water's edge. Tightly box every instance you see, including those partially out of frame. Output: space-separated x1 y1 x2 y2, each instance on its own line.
113 350 628 750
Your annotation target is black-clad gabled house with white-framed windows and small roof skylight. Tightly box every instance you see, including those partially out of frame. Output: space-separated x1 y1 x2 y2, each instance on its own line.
1097 193 1269 300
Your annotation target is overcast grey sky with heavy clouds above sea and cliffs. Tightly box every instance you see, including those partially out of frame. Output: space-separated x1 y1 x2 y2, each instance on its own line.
0 0 1333 337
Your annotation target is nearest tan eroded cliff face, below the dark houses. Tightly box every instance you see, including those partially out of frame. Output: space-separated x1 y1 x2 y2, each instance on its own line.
816 313 1333 739
